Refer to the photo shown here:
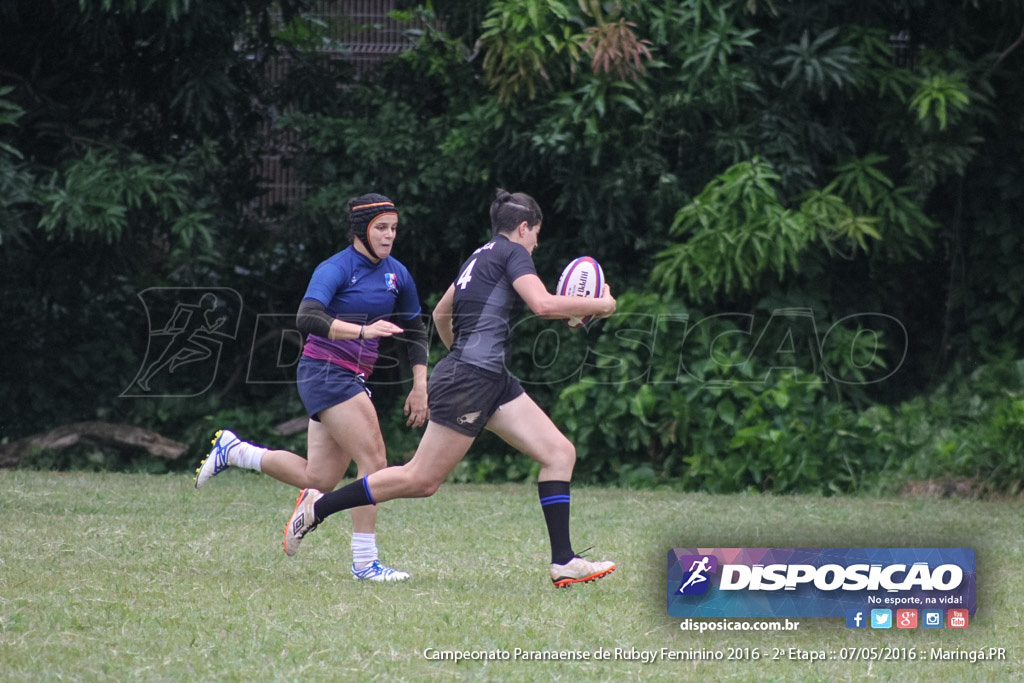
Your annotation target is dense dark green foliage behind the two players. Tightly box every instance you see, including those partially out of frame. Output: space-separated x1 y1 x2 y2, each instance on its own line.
0 0 1024 492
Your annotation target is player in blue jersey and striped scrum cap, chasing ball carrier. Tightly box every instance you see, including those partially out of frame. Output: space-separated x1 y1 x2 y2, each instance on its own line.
196 194 429 581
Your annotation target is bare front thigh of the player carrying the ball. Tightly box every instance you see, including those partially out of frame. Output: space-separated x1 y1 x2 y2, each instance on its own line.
486 393 575 465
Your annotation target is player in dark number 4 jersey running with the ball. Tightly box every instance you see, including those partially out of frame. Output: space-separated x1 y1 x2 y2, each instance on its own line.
285 190 615 588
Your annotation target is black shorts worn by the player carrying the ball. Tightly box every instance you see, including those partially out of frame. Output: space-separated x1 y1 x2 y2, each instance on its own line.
427 356 524 436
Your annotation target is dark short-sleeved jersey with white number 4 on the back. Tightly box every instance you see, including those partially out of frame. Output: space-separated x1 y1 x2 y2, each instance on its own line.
451 234 537 372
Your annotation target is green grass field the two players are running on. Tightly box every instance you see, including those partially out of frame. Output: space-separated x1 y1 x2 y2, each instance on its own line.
0 471 1024 681
